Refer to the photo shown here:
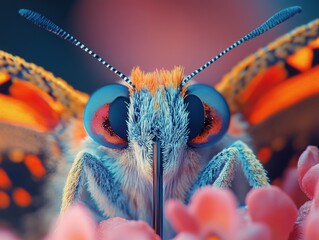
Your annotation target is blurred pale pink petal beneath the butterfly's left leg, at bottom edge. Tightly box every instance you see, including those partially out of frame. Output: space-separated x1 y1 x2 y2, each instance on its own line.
46 204 96 240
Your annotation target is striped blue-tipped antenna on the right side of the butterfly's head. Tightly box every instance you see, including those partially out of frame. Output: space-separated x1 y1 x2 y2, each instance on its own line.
179 6 302 89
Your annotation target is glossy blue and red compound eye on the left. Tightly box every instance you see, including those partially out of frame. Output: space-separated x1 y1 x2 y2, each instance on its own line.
84 84 129 148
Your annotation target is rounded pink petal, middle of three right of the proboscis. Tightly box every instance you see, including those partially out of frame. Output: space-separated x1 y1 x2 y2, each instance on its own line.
189 187 237 237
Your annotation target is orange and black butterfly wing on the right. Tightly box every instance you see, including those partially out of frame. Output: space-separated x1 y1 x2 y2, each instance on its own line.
217 20 319 180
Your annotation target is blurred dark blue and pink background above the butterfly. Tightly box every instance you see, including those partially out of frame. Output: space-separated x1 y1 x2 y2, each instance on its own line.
0 0 319 93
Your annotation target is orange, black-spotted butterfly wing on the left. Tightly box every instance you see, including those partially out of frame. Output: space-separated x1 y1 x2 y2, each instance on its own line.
0 51 88 239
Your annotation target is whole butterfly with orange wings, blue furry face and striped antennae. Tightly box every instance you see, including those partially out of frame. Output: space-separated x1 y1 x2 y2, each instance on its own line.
0 4 319 239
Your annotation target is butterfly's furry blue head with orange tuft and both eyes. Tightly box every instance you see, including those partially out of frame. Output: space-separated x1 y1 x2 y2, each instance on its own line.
84 67 230 151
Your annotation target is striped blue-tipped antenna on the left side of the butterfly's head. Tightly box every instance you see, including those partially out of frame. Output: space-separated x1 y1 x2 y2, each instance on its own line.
19 9 135 89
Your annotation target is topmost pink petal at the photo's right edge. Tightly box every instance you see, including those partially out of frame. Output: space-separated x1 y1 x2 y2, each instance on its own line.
298 146 319 183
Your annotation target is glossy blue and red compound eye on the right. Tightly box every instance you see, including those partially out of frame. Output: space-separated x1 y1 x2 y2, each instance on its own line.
184 84 230 147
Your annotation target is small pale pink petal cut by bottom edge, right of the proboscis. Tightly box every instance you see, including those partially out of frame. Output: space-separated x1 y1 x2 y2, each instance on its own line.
233 223 271 240
